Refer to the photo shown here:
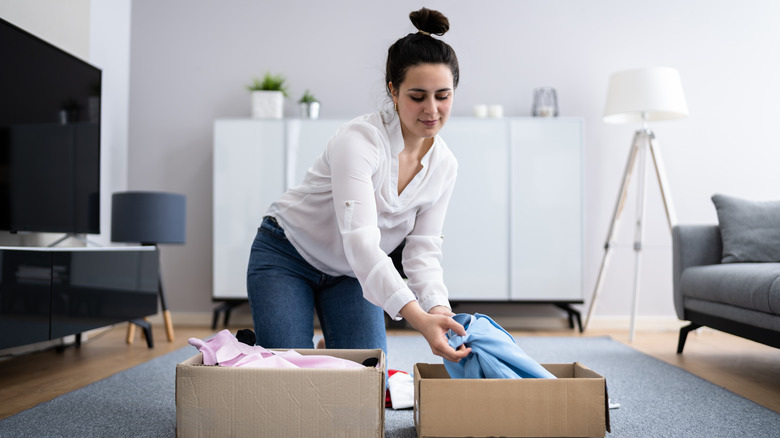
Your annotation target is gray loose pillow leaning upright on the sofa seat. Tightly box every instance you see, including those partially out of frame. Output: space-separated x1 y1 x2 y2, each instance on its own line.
712 194 780 263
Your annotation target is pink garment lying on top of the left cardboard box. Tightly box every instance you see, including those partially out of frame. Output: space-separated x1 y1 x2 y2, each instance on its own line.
189 330 365 369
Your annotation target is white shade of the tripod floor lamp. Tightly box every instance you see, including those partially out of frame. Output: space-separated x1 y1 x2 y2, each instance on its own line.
604 67 688 123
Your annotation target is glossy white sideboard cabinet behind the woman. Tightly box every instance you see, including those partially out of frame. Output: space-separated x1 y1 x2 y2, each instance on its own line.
213 117 584 324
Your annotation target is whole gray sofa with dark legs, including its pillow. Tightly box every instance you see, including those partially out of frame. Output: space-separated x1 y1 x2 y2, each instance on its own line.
672 194 780 354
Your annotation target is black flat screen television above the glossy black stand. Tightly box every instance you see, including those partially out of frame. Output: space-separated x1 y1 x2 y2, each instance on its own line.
0 19 102 234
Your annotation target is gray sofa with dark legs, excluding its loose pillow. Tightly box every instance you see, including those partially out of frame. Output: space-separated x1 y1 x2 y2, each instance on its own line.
672 222 780 354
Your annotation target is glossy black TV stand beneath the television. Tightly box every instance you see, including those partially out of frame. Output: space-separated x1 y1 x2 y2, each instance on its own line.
0 246 160 349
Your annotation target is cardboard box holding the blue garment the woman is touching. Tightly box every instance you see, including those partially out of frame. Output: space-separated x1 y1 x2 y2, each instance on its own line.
414 362 610 438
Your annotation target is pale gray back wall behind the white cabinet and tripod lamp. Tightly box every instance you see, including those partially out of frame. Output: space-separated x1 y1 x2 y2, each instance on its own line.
6 0 780 326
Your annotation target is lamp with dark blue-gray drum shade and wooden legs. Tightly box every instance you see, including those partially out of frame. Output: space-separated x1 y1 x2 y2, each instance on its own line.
111 192 187 343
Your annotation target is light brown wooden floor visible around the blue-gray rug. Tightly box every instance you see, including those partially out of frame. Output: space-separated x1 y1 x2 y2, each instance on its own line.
0 324 780 418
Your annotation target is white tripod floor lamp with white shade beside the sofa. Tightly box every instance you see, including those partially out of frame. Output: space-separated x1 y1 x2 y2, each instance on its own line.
585 67 688 341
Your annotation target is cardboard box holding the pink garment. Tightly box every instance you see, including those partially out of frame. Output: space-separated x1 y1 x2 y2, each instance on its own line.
176 349 385 437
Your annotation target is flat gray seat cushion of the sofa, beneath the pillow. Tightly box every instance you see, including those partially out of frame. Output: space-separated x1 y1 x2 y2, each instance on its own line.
680 263 780 315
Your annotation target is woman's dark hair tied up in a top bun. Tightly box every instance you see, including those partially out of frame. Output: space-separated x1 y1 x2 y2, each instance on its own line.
385 8 460 94
